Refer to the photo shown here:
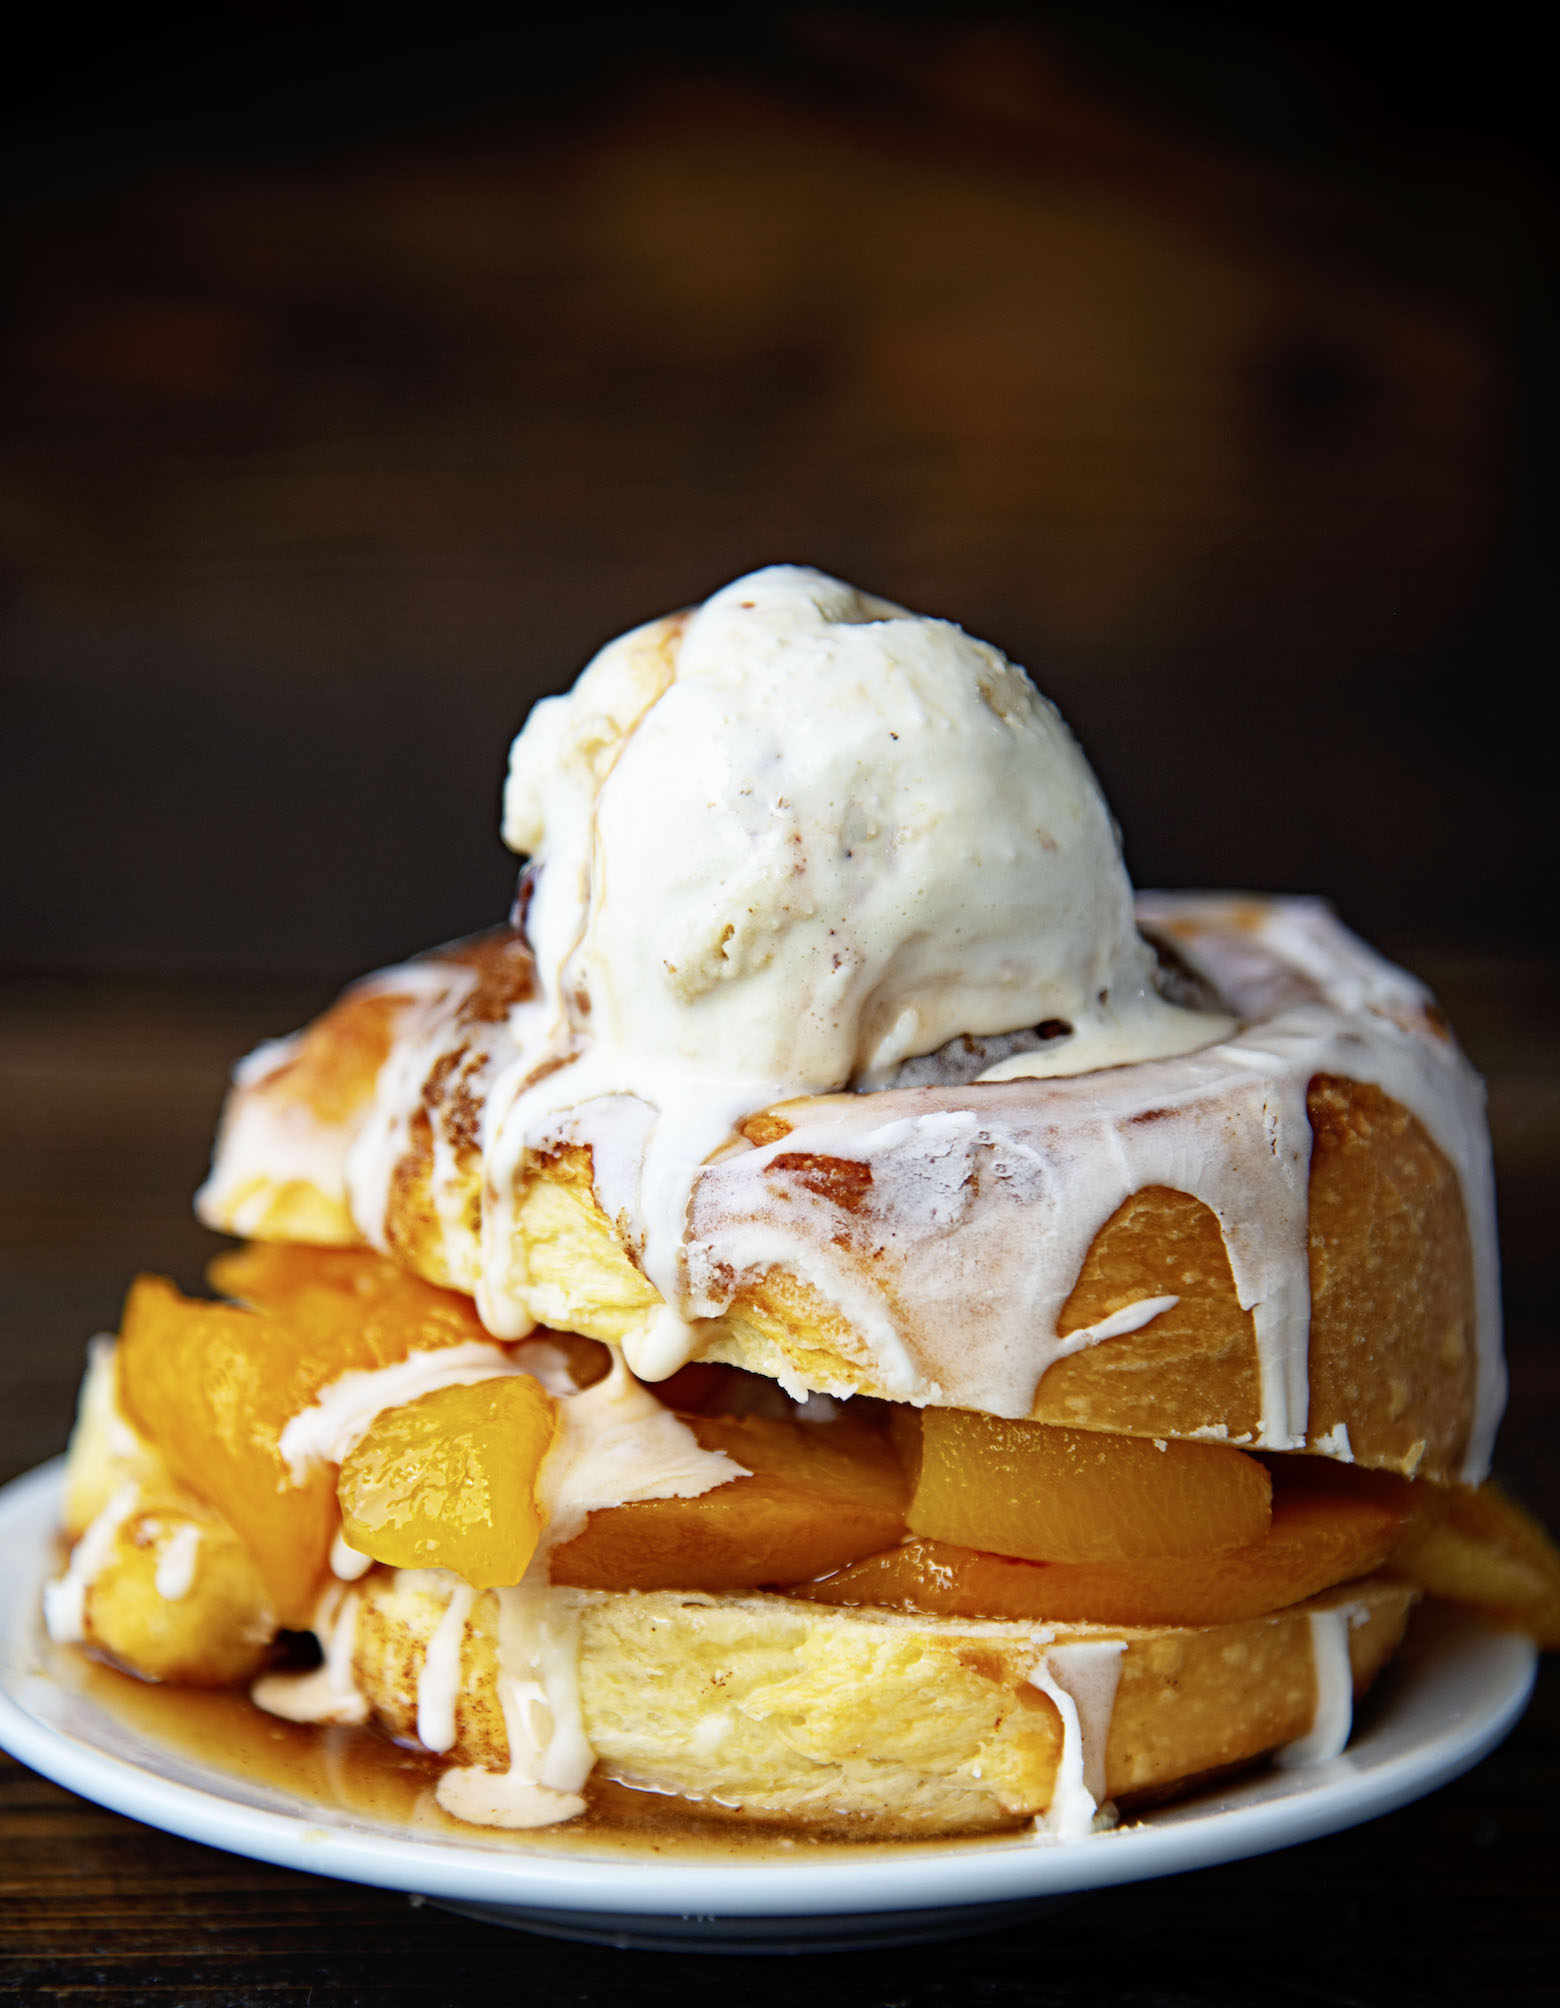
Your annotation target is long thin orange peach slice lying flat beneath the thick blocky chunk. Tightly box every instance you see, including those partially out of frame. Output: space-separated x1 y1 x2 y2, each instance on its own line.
793 1494 1403 1624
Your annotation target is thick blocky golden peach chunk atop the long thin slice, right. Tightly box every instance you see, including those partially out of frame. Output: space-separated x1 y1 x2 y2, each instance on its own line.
905 1408 1271 1562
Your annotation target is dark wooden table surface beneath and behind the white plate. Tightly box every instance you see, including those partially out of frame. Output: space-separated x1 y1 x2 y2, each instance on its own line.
0 956 1560 2008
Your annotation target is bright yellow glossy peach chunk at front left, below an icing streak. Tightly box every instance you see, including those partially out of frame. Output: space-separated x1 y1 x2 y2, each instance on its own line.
337 1373 558 1590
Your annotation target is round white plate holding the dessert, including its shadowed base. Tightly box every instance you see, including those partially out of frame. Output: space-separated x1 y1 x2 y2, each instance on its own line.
0 1464 1536 1952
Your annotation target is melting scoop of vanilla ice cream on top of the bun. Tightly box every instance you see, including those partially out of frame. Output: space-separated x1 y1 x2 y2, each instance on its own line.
504 566 1229 1092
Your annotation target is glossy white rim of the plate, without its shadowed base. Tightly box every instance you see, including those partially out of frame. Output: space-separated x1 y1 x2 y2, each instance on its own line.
0 1458 1538 1918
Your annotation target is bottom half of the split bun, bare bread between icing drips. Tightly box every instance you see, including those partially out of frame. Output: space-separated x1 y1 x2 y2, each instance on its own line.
353 1572 1413 1833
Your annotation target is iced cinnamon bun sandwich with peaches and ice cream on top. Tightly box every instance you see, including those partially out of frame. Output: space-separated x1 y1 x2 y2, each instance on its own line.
46 566 1560 1837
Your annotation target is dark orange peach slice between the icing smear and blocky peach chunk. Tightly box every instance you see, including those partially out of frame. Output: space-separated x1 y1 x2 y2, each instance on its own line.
552 1416 909 1590
